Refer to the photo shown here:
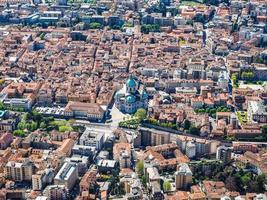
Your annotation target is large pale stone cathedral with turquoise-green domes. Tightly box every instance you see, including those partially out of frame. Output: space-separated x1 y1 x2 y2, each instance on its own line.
115 76 148 114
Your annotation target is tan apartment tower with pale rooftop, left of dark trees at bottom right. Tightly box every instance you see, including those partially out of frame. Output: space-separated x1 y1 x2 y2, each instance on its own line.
175 163 193 189
